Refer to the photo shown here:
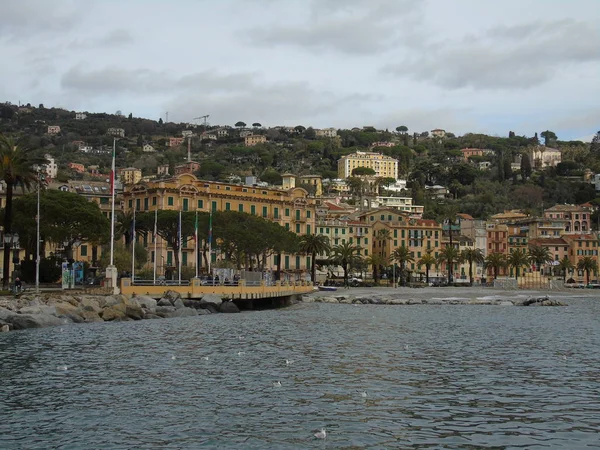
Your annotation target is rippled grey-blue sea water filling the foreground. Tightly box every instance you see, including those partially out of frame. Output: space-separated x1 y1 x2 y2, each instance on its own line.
0 299 600 449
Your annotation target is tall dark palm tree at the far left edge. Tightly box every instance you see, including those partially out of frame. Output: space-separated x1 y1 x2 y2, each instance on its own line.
0 135 47 289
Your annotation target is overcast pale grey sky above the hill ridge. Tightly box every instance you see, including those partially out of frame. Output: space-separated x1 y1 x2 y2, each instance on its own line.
0 0 600 139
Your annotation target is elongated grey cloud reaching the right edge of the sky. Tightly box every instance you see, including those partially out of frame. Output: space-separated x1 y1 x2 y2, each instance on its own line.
382 20 600 89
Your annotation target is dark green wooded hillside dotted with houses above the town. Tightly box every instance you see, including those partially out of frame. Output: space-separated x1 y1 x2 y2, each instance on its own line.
0 103 600 218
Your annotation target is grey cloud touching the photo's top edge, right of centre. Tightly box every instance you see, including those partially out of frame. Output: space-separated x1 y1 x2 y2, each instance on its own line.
246 0 418 55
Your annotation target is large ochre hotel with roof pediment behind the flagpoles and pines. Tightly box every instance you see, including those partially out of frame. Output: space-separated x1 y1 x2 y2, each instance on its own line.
123 174 315 272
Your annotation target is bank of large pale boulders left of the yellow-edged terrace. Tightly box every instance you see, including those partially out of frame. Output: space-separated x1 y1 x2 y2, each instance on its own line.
0 291 239 331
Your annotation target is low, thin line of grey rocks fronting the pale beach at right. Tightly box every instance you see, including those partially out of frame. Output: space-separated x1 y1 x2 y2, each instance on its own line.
302 294 567 306
